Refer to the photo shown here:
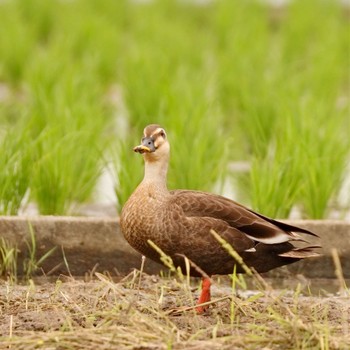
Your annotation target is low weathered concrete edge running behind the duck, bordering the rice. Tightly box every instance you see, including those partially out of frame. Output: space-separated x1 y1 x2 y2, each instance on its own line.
0 216 350 278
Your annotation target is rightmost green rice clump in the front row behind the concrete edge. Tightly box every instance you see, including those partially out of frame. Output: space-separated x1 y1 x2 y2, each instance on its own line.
299 101 350 219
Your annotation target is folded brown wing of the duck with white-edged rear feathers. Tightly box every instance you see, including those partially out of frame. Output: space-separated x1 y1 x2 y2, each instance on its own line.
170 190 317 244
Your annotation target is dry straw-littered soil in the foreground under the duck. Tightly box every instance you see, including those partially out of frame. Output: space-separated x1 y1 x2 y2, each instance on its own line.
0 271 350 349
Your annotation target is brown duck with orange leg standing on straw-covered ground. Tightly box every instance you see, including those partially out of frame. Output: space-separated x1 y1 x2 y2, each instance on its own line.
120 124 318 312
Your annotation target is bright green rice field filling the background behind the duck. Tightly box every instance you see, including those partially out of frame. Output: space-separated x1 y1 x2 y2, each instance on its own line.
0 0 349 218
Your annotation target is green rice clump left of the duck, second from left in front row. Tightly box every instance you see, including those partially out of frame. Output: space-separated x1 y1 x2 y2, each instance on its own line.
31 129 102 215
